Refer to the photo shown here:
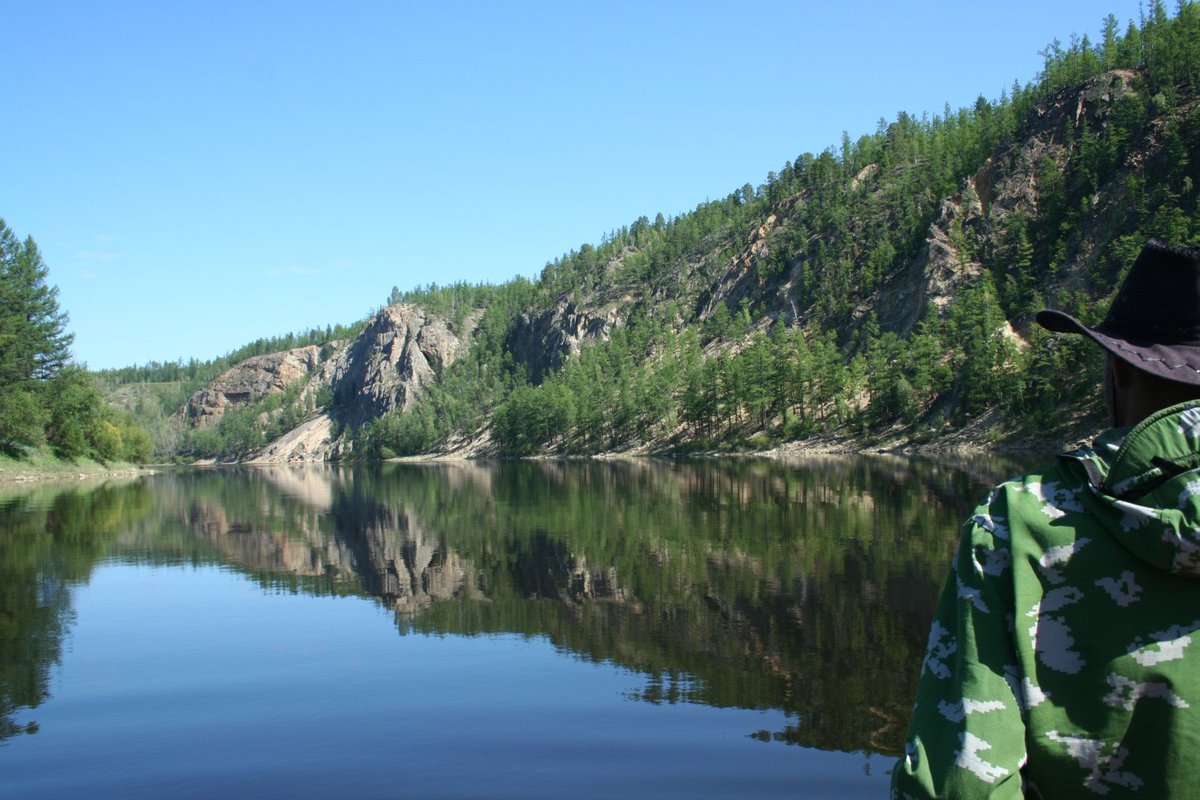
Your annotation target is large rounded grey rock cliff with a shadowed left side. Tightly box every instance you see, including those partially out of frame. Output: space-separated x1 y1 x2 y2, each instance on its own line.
328 305 467 425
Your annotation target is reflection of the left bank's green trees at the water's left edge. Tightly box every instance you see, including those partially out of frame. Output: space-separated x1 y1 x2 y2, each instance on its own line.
0 483 150 740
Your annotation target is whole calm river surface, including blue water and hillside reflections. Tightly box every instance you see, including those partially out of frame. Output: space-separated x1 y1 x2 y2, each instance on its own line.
0 458 1027 799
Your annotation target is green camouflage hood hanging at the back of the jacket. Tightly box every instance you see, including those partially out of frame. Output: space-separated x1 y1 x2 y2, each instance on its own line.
1067 402 1200 577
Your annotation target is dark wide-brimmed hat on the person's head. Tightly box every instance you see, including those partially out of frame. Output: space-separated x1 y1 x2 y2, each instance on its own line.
1036 239 1200 386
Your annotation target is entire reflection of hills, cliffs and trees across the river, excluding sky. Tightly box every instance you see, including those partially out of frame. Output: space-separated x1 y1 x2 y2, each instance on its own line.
0 457 1032 753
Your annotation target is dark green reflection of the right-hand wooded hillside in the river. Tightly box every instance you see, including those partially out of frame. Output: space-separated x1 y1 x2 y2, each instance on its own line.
350 458 1012 752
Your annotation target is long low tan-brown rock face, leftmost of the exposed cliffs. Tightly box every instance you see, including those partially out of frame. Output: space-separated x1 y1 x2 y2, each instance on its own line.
184 345 320 423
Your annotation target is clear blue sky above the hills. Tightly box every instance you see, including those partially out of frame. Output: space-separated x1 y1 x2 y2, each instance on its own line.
0 0 1147 368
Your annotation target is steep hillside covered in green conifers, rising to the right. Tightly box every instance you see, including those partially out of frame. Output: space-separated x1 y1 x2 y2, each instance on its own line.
106 1 1200 458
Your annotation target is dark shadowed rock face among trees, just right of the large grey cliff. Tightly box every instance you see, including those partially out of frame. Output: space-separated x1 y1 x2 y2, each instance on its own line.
506 302 617 384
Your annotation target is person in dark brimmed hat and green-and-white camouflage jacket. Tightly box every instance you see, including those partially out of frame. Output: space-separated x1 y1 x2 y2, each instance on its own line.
892 240 1200 800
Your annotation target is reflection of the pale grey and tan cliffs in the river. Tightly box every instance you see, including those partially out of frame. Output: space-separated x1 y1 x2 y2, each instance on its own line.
121 465 482 609
